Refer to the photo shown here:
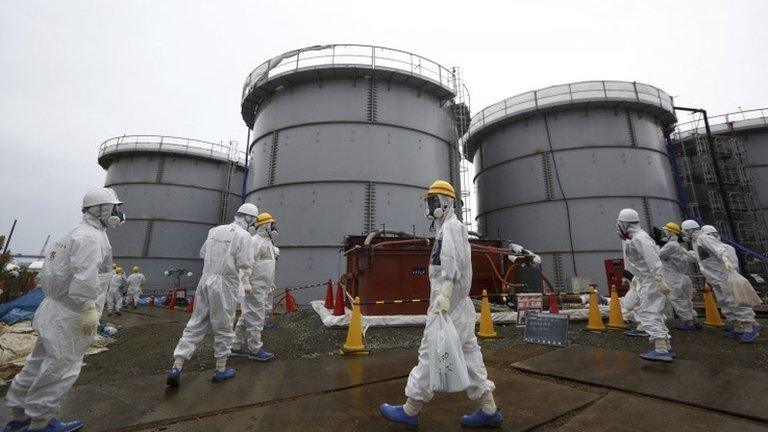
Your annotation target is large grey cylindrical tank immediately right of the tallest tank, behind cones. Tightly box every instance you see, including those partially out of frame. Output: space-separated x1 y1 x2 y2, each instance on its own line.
466 81 680 293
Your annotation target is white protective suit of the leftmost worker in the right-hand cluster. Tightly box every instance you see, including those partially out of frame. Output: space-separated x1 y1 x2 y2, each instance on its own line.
622 225 669 341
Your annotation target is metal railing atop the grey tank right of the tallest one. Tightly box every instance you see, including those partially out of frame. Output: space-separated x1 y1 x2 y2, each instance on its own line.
467 81 674 140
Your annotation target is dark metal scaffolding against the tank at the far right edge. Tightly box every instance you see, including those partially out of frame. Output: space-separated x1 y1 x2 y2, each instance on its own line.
675 126 768 275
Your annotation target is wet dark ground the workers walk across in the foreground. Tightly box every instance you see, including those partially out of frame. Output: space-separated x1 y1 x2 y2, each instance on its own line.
0 307 768 432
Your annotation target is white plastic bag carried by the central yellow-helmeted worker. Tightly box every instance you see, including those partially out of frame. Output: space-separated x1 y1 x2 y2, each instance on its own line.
427 313 469 393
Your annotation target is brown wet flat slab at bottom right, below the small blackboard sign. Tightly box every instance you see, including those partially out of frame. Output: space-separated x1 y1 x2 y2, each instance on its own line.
514 346 768 421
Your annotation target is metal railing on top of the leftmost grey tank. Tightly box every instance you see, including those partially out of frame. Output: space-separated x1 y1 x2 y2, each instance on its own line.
99 135 245 166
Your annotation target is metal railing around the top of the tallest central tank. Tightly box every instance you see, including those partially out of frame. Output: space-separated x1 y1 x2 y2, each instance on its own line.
242 44 456 100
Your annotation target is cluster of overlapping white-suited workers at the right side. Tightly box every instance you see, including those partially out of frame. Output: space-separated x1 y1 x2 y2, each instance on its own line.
617 209 763 362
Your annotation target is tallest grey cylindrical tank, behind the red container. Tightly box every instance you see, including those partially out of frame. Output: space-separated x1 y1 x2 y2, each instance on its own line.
242 45 459 303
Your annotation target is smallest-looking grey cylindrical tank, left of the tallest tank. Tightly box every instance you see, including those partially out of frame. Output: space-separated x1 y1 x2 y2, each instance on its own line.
99 135 245 293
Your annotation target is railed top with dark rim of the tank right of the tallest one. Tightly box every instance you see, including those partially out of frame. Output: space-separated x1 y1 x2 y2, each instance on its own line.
464 81 677 160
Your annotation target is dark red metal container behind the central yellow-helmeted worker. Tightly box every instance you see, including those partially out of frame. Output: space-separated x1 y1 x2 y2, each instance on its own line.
344 236 509 315
